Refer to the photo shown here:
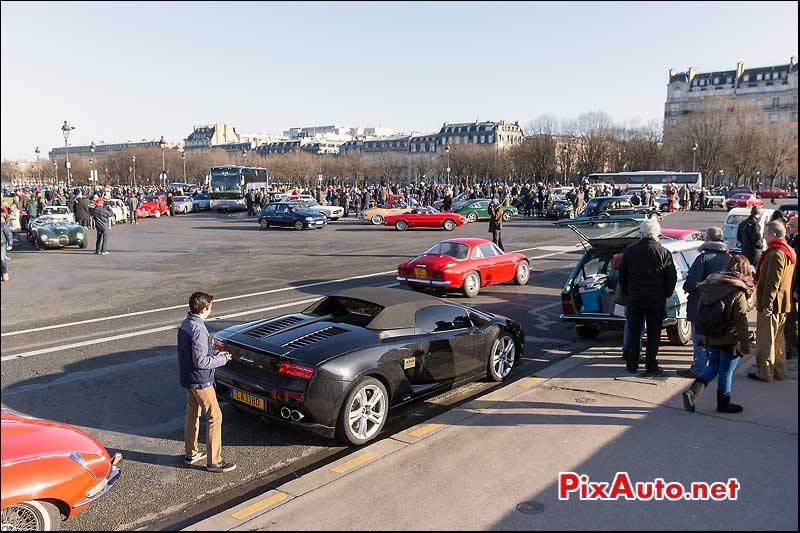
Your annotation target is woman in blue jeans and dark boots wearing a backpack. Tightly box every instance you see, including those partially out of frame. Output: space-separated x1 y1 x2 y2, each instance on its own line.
683 255 755 413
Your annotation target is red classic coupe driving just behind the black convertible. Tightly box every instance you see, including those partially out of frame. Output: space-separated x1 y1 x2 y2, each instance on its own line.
397 239 531 298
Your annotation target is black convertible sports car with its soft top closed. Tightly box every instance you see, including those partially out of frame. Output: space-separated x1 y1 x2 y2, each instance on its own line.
212 288 525 444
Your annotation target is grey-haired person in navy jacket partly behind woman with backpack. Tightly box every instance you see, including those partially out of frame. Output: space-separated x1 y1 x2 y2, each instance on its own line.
678 227 731 379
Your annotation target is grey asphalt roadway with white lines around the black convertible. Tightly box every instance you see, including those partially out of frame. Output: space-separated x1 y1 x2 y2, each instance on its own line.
0 204 768 530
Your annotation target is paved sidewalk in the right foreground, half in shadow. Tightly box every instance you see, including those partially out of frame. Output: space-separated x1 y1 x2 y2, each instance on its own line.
188 346 798 531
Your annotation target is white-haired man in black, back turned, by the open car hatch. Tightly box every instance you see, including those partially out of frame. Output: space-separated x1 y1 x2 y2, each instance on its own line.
619 217 678 376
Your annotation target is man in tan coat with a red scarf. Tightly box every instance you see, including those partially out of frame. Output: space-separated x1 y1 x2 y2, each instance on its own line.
747 220 797 382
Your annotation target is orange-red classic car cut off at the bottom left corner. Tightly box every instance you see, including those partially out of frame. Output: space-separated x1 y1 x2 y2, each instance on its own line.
0 409 122 531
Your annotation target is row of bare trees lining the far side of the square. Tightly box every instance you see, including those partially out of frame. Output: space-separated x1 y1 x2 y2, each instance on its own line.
2 111 798 185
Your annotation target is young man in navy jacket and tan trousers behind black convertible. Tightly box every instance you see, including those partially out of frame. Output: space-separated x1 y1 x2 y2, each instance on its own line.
178 292 236 472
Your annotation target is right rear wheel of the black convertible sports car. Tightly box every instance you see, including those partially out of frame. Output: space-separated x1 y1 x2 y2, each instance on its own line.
336 377 389 446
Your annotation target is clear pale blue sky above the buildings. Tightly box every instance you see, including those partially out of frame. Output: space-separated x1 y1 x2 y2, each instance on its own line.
0 2 798 159
